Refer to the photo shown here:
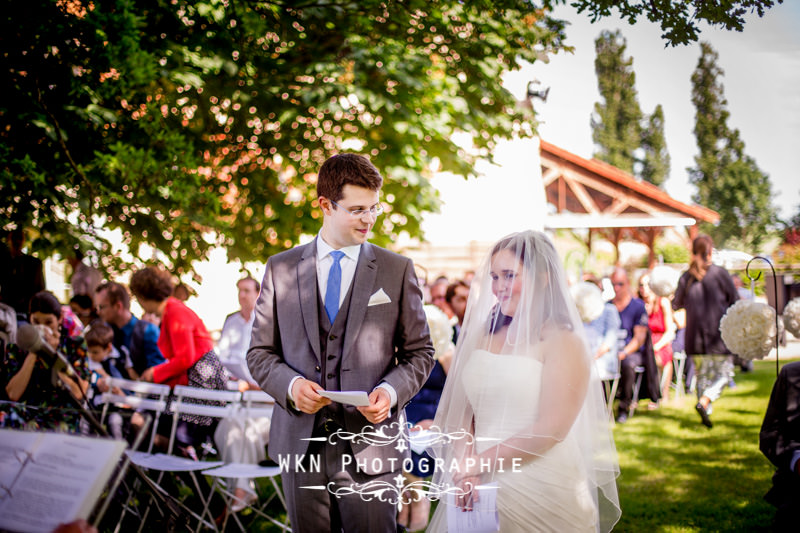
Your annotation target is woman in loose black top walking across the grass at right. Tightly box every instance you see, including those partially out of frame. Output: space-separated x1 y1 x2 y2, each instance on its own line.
672 235 739 428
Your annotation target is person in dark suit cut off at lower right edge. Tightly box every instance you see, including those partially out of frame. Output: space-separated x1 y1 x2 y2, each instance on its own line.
759 361 800 531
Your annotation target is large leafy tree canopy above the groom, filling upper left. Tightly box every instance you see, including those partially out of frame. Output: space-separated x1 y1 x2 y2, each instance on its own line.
0 0 564 272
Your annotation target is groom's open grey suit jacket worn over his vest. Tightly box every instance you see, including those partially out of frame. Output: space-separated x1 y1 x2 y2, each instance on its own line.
247 239 434 474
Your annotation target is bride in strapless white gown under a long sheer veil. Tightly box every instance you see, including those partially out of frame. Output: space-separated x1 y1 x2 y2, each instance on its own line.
428 231 620 532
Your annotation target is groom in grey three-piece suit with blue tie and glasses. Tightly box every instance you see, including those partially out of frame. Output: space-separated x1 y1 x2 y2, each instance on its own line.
247 153 433 532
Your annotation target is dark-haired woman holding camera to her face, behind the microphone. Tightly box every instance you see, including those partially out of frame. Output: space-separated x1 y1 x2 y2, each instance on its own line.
0 291 89 433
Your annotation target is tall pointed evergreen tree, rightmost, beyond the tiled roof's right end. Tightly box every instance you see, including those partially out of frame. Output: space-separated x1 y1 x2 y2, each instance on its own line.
688 43 776 252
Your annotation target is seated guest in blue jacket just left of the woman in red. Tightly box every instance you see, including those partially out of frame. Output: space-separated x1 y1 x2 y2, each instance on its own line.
94 281 165 379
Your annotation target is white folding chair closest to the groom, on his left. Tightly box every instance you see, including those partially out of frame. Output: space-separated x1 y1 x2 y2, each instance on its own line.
203 390 291 531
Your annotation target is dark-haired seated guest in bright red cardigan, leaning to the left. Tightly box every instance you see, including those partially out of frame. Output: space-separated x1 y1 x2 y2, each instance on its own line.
130 267 227 455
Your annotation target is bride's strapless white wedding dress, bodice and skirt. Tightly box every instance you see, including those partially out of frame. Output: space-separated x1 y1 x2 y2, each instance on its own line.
429 350 598 533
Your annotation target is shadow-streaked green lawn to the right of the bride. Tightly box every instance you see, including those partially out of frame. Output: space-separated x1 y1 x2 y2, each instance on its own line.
614 361 775 532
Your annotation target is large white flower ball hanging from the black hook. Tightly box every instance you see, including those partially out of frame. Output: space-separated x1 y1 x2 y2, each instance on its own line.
719 300 778 359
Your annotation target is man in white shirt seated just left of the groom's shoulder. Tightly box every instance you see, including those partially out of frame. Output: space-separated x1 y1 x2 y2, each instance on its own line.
218 276 261 388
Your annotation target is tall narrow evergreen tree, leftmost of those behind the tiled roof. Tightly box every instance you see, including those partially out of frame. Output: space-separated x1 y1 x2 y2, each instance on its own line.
592 30 642 174
